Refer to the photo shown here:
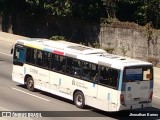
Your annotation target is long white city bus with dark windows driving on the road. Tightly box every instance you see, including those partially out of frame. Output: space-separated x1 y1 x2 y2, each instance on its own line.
12 38 153 111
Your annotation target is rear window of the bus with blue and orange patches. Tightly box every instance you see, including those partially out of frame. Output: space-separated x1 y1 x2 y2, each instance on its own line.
123 66 153 82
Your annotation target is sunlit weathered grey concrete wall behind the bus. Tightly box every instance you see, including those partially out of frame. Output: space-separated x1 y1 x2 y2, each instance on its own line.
99 26 160 61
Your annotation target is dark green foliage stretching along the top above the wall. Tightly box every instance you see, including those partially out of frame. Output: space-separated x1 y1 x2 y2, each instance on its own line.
0 0 160 29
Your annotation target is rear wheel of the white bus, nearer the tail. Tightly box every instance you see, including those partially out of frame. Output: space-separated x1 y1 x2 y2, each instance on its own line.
74 91 85 108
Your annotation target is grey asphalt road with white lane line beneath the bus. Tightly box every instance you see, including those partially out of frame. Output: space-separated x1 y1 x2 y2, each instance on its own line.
0 52 160 120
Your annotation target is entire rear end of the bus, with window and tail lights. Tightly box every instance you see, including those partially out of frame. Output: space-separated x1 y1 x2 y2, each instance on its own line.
120 66 153 110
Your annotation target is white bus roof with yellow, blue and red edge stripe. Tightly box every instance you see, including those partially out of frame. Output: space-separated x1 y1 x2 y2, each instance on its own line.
17 38 152 69
